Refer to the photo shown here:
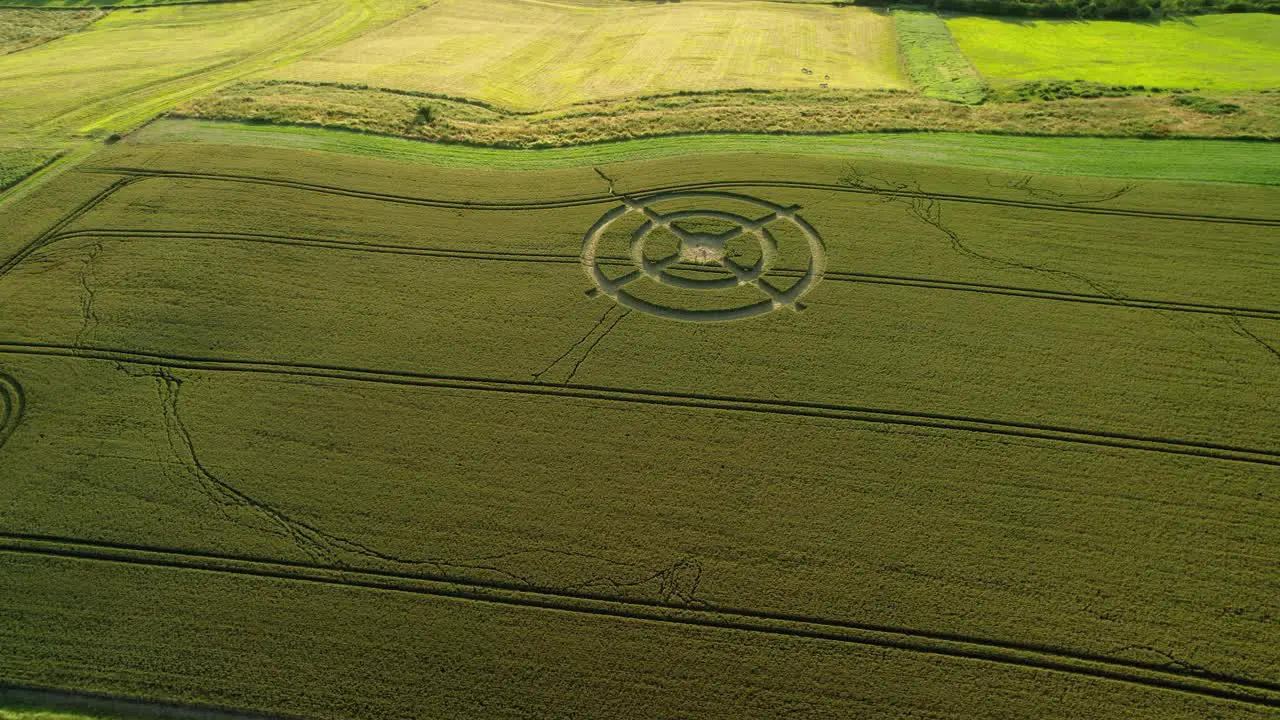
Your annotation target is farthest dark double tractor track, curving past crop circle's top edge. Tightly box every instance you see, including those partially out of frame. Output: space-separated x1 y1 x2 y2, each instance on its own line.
74 167 1280 227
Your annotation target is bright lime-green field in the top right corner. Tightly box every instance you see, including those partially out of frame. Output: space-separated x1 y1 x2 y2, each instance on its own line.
947 14 1280 90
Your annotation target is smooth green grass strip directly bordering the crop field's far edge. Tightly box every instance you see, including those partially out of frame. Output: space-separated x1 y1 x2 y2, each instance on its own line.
129 115 1280 184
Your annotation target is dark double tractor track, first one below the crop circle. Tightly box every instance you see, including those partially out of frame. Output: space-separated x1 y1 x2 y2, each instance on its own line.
0 342 1280 468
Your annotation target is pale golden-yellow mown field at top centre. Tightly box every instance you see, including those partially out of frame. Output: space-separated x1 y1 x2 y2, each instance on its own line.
273 0 904 110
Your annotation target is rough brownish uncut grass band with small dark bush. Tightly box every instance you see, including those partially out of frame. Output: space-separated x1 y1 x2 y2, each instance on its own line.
177 83 1280 147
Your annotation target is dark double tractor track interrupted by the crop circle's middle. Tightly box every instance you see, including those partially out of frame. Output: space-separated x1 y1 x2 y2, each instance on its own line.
24 228 1280 320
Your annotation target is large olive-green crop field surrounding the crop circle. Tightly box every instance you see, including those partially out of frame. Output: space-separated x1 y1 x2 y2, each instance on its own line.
0 134 1280 719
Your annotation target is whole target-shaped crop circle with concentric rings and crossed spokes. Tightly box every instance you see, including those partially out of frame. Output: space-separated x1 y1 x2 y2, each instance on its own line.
582 191 827 323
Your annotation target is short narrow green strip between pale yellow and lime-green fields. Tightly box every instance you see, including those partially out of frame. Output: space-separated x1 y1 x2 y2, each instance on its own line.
893 8 987 102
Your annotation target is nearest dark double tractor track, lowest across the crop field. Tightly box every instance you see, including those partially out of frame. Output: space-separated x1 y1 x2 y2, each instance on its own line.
0 534 1280 707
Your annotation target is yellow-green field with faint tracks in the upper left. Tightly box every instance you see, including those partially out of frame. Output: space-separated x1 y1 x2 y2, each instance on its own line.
0 0 417 136
